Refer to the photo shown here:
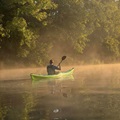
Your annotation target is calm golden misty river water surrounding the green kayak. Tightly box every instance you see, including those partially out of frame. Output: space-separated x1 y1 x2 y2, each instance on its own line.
0 64 120 120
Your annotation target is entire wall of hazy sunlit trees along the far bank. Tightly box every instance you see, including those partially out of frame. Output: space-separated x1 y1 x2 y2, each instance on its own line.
0 0 120 68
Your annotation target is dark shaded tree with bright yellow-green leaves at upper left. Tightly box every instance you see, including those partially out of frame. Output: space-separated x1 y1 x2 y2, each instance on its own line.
0 0 57 65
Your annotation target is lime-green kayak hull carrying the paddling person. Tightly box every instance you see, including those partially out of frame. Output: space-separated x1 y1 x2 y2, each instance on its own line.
30 68 74 81
